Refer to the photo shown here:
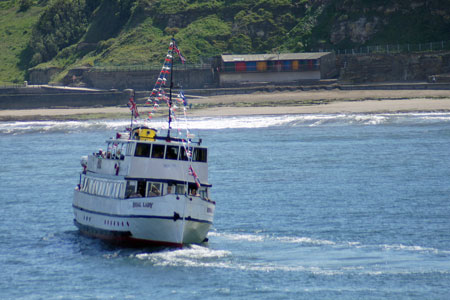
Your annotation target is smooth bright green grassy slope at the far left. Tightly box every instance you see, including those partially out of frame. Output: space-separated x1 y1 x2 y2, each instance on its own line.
0 1 43 85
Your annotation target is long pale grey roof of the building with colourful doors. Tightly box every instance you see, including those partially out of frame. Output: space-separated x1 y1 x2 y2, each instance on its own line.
222 52 331 62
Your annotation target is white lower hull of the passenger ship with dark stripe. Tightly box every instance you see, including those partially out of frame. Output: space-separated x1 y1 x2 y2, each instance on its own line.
73 190 215 247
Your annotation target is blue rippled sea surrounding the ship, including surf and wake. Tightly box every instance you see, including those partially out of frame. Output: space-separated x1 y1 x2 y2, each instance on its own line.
0 113 450 299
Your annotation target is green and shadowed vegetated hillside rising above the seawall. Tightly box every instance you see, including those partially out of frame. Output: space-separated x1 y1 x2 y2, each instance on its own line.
0 0 450 84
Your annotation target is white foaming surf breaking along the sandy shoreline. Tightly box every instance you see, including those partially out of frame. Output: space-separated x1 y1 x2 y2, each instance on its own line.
0 113 450 134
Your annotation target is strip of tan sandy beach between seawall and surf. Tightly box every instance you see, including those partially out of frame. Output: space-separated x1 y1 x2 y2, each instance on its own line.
0 89 450 121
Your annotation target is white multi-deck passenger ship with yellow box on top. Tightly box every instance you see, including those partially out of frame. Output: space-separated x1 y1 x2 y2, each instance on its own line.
73 38 215 247
